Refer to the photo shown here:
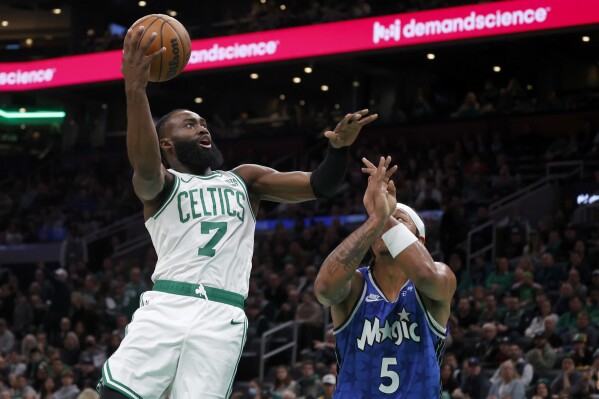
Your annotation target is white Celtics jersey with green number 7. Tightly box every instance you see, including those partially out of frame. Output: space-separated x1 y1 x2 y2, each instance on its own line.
146 169 256 298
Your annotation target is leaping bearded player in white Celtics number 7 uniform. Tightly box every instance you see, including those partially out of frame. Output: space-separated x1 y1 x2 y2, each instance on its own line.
99 27 377 399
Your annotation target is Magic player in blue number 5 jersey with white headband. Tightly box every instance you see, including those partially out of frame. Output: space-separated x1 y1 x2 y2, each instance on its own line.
314 157 456 399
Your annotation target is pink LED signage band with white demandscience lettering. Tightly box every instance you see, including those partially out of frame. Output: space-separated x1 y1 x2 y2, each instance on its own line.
0 0 599 91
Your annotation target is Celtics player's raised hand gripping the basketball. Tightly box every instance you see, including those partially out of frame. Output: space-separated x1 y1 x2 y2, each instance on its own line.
121 26 166 88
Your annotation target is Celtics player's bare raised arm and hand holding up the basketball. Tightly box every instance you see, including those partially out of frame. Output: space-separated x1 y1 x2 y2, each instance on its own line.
121 27 167 202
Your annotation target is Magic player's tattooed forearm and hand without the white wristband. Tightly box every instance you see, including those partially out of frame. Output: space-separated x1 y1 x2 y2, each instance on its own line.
314 158 392 305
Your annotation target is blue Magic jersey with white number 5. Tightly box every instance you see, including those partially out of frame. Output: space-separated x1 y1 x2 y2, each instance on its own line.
333 267 447 399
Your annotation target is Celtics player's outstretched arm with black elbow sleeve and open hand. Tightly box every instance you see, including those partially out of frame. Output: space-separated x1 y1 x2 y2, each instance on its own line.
235 109 378 202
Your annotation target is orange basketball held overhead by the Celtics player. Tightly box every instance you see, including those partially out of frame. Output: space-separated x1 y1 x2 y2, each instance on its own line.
131 14 191 82
